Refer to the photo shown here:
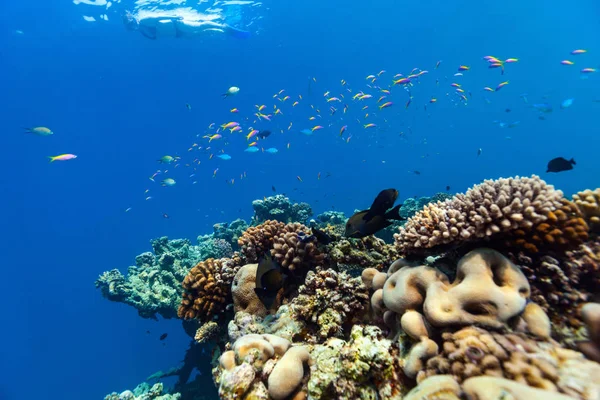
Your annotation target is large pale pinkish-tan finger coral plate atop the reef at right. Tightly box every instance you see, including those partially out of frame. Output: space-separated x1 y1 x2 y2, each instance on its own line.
395 175 563 253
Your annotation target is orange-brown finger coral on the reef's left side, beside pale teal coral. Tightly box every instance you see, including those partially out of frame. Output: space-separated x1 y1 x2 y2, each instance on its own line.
177 258 230 321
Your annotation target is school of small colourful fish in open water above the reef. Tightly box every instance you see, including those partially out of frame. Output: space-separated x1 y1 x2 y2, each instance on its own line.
25 49 597 216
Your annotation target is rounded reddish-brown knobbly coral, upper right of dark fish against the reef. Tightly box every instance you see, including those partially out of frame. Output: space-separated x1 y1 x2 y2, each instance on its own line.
271 223 325 271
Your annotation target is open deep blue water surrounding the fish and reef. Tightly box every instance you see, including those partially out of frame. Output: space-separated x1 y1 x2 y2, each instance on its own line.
0 0 600 400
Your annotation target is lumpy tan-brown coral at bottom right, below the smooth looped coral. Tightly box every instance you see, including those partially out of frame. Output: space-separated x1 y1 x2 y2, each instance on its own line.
417 327 600 398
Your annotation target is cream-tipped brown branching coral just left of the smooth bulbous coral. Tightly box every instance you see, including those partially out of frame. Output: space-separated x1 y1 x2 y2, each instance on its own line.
290 269 369 340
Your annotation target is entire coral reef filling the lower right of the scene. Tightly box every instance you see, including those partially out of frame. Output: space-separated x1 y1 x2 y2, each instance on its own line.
97 176 600 400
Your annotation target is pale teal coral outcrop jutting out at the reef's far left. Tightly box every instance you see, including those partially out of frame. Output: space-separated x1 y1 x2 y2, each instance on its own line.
95 237 203 319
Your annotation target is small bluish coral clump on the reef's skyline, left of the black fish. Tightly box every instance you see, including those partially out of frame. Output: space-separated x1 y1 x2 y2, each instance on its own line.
252 194 312 225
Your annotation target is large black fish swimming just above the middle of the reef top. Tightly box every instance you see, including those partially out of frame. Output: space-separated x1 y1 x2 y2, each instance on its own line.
345 189 404 239
